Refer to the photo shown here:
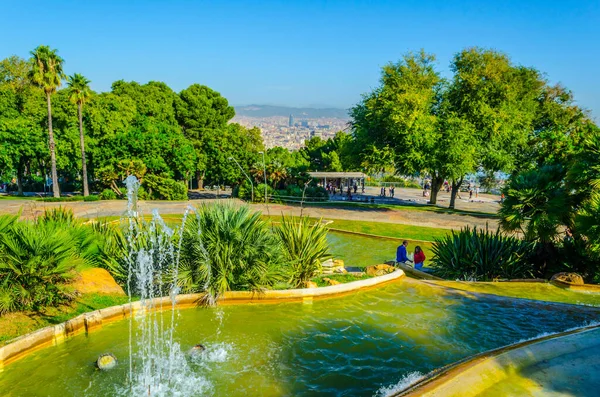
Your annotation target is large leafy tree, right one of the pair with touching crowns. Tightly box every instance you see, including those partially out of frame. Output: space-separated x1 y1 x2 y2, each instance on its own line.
442 48 544 208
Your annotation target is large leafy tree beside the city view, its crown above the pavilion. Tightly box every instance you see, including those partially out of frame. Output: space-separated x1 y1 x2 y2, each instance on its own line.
351 51 446 204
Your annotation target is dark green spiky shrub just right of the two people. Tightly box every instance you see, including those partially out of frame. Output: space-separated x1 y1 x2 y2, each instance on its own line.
433 226 533 280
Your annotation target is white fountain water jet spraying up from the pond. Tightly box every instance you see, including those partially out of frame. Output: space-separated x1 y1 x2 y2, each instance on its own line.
121 176 211 396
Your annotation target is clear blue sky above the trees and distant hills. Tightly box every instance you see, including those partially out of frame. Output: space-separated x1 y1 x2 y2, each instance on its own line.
0 0 600 119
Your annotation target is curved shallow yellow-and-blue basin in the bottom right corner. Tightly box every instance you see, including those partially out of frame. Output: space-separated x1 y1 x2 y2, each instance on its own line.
397 326 600 397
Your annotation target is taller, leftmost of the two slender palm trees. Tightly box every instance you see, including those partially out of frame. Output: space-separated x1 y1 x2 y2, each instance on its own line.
29 45 65 197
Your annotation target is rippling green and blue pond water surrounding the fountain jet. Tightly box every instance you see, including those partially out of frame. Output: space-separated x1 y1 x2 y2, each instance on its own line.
0 279 598 397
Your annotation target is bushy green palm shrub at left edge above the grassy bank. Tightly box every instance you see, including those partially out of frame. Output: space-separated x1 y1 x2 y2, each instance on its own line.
0 222 84 313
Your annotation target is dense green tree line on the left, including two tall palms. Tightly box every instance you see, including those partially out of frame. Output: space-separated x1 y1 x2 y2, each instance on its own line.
0 46 264 196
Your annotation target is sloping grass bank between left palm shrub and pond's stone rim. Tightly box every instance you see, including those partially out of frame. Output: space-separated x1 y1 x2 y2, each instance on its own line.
0 294 128 345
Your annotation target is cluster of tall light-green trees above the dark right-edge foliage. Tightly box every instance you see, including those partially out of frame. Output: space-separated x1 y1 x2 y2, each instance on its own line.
351 48 597 208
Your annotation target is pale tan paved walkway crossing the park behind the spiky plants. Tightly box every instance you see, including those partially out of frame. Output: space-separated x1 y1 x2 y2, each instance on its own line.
0 193 497 229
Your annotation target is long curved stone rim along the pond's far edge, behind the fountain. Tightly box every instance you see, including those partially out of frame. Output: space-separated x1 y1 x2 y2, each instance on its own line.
0 270 404 371
